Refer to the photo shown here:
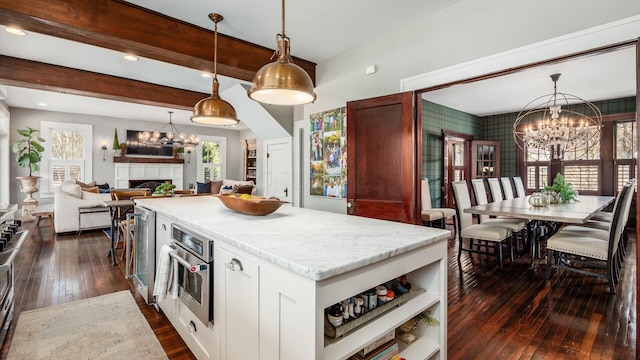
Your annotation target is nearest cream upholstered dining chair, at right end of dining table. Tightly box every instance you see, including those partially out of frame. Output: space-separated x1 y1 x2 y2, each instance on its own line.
545 181 633 294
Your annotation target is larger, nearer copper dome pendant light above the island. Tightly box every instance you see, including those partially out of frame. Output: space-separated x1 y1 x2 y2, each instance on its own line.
247 0 316 105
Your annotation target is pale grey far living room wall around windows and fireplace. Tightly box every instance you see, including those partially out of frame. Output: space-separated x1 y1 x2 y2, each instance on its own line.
8 108 243 203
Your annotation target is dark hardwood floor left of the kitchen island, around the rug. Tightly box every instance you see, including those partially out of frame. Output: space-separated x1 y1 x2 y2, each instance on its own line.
0 222 195 360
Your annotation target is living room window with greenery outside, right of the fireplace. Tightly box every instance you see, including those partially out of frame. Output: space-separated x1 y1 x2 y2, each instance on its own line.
196 136 227 182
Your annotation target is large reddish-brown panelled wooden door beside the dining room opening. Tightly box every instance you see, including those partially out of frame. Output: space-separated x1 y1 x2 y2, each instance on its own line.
347 92 420 224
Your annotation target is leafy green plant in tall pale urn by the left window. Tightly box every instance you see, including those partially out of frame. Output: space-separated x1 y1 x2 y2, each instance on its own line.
11 126 44 215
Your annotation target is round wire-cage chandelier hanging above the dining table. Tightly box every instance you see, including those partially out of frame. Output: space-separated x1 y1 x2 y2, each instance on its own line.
513 74 602 160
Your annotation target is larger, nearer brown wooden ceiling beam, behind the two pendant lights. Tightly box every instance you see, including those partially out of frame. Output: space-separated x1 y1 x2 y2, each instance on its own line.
0 0 316 84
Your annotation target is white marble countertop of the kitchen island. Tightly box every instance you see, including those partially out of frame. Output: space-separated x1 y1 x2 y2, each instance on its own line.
136 196 451 280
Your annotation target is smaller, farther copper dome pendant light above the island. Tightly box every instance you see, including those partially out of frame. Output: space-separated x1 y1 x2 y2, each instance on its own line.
191 13 240 125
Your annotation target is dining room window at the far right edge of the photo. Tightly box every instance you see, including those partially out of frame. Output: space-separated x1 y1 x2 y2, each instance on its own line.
614 121 638 191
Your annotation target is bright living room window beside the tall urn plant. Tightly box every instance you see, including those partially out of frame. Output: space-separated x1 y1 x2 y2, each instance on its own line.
40 121 93 197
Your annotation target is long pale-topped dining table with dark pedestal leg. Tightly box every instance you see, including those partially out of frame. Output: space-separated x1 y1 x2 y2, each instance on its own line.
464 195 615 268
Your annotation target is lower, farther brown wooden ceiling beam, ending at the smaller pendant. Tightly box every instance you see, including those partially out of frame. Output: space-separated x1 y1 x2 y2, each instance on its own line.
0 55 209 111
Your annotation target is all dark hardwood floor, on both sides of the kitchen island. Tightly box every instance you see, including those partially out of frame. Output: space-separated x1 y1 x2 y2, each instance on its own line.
0 218 637 360
